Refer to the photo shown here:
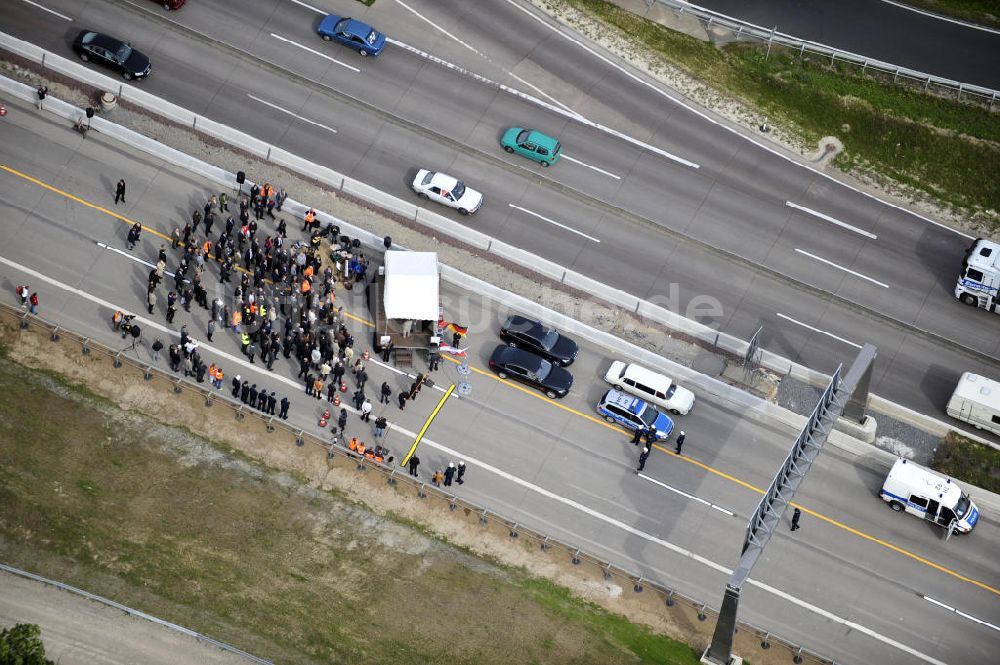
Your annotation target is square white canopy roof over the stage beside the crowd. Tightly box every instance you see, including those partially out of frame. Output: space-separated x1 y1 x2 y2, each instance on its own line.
383 251 440 321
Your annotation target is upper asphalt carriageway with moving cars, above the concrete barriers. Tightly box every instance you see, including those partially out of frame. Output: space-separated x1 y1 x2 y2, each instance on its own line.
5 0 1000 430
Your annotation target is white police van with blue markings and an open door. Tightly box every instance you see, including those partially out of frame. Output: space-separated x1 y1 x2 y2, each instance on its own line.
879 458 979 533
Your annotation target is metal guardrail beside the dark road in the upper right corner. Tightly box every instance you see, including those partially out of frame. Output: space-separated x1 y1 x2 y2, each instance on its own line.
645 0 1000 106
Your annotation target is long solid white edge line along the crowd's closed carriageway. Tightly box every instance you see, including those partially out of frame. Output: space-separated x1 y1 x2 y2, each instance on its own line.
0 256 960 665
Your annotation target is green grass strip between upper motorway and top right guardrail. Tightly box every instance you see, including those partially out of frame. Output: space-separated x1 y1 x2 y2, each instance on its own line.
566 0 1000 223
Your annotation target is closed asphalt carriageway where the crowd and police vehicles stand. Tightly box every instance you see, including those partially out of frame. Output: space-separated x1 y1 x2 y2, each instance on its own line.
0 104 1000 664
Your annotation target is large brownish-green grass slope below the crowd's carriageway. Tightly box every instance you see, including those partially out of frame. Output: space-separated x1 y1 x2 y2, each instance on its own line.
0 354 698 665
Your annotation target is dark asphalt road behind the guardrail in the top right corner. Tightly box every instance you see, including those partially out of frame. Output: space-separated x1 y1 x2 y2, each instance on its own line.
692 0 1000 90
